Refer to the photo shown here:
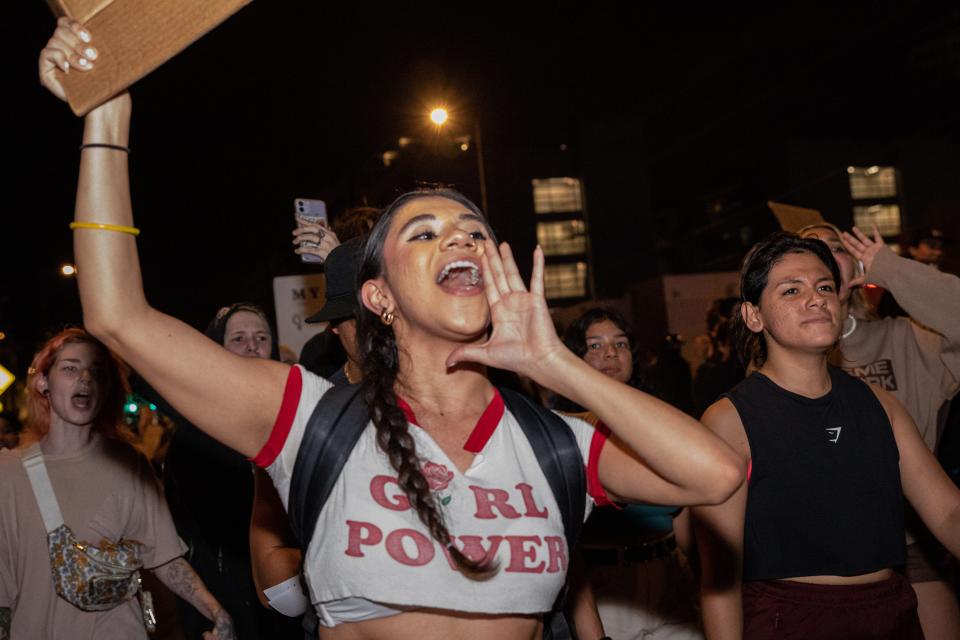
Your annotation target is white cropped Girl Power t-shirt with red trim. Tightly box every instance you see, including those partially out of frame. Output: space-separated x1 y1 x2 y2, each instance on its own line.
254 366 607 614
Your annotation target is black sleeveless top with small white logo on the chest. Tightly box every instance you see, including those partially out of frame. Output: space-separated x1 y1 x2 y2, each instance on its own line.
724 367 905 581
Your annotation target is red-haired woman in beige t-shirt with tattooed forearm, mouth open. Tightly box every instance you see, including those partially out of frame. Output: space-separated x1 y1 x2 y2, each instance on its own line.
0 328 234 640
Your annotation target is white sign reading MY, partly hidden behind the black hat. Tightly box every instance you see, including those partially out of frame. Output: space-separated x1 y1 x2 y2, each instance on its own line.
273 273 329 356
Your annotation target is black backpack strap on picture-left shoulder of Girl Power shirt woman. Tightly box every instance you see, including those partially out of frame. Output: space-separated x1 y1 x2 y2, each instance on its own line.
287 384 370 551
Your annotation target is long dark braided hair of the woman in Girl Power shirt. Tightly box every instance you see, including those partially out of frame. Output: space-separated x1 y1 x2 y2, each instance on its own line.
356 189 496 580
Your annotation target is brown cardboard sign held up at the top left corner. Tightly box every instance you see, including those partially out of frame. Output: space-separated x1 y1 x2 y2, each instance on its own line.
47 0 251 116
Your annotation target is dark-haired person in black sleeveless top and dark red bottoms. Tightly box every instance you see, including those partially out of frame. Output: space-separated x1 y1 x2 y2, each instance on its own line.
694 233 960 640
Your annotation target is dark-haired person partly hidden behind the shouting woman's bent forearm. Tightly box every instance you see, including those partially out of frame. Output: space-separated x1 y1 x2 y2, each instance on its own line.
559 307 703 640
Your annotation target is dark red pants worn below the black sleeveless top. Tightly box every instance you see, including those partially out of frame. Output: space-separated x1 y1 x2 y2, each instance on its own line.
743 574 923 640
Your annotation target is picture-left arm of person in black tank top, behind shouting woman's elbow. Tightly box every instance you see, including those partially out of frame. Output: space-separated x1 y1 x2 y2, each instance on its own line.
691 399 750 640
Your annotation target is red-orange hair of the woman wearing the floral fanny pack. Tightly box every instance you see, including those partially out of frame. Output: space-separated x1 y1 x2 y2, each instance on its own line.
26 327 130 440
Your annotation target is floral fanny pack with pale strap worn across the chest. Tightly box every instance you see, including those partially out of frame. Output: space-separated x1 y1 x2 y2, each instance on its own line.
23 444 155 630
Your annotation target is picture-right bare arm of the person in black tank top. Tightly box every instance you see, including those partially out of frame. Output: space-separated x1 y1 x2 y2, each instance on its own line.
871 385 960 557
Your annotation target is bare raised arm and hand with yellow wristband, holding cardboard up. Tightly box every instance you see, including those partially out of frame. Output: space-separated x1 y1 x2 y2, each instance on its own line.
40 18 288 456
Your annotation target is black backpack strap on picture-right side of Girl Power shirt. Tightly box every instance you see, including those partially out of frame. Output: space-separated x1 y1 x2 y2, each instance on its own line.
500 389 587 550
